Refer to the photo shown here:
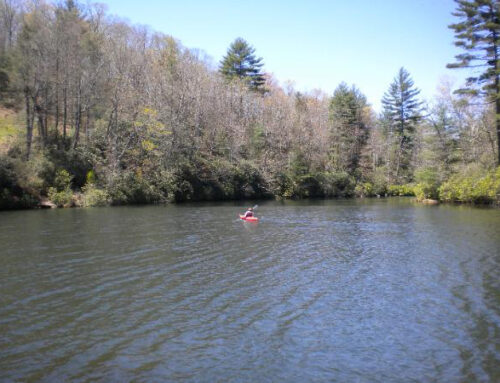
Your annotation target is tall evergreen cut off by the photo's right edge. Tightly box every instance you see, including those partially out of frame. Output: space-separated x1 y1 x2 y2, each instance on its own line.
447 0 500 165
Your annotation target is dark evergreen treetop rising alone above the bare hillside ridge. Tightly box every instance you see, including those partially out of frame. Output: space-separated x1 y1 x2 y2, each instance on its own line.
219 37 265 91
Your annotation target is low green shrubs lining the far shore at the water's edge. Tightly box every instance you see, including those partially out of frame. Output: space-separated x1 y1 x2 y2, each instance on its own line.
0 164 500 209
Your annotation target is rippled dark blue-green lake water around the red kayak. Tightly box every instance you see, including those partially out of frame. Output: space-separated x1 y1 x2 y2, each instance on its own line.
0 199 500 382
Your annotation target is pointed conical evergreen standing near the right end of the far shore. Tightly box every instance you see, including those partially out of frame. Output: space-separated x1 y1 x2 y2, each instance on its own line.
382 68 422 182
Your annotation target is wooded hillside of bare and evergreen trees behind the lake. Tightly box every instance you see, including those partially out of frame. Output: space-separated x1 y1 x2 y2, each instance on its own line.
0 0 500 209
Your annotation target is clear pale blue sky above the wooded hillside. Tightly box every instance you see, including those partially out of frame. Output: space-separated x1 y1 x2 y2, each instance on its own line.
101 0 467 110
